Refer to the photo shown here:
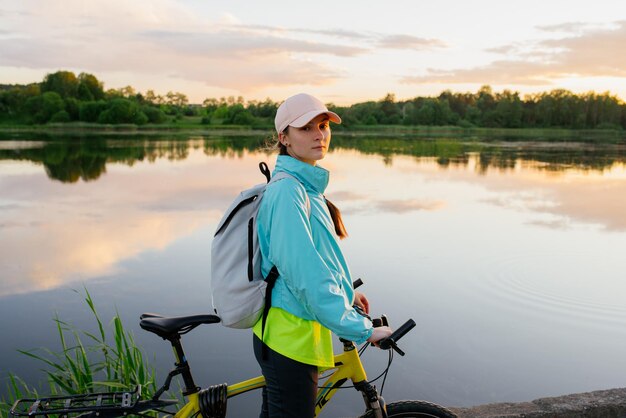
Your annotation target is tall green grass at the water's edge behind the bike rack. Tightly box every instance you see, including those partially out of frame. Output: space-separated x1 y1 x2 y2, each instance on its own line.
0 289 157 418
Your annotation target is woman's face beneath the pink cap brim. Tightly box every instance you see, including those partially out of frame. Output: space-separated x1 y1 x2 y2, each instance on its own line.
278 113 330 165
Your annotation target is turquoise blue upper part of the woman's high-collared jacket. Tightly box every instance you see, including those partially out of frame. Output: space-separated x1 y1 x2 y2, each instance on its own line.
257 155 372 344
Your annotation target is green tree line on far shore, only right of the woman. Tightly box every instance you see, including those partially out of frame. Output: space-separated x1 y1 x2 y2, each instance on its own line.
336 86 626 129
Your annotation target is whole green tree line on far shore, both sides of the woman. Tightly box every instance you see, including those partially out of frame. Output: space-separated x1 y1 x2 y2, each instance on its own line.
0 71 626 129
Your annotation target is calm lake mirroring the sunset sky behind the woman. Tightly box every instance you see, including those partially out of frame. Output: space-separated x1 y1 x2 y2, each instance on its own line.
0 133 626 416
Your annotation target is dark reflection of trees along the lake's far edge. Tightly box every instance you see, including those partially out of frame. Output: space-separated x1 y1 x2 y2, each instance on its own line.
0 134 626 183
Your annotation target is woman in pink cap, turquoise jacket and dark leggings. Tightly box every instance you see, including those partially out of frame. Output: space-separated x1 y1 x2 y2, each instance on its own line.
254 94 391 418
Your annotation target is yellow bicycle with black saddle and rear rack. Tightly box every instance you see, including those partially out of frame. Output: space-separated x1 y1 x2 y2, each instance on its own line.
10 304 455 418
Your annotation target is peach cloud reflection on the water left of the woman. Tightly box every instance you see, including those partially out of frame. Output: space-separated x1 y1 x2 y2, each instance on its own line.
0 149 261 297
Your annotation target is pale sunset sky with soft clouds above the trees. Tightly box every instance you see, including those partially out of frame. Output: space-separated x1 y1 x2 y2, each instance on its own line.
0 0 626 105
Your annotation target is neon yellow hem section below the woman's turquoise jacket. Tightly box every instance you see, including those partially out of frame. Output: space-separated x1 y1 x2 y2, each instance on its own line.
253 307 335 368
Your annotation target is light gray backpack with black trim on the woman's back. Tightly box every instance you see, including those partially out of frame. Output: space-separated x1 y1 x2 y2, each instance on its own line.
211 163 310 329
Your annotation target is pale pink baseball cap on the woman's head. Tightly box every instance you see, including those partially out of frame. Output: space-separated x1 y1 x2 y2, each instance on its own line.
274 93 341 133
